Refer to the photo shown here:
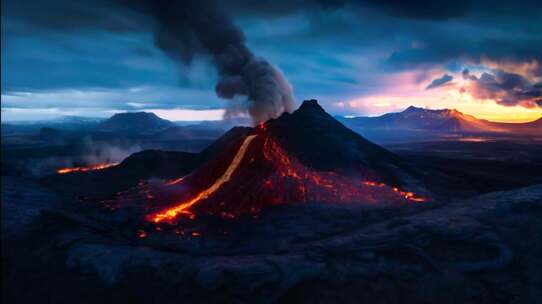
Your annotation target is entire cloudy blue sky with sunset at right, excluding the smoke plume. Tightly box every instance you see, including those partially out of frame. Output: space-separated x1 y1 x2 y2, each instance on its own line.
1 0 542 122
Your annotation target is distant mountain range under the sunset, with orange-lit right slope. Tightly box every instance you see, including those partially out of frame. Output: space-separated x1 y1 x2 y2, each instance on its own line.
339 106 542 134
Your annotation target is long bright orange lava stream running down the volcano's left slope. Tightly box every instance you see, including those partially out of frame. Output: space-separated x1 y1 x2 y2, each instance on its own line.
152 135 256 223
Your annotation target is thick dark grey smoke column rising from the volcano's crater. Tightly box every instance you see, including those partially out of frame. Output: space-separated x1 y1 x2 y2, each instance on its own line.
121 0 294 123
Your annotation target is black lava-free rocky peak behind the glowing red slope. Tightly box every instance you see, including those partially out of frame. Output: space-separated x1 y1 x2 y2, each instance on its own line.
265 99 412 185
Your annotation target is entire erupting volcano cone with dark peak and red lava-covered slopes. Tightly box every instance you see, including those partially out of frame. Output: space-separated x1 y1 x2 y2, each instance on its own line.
149 100 425 223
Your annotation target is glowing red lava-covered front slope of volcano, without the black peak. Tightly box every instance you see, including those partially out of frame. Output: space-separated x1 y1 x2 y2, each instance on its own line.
149 126 426 223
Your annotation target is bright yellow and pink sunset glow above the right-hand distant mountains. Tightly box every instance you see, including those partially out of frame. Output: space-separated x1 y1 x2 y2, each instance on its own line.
332 66 542 123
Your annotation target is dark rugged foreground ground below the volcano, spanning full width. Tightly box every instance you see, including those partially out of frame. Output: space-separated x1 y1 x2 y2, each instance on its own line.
2 178 542 303
